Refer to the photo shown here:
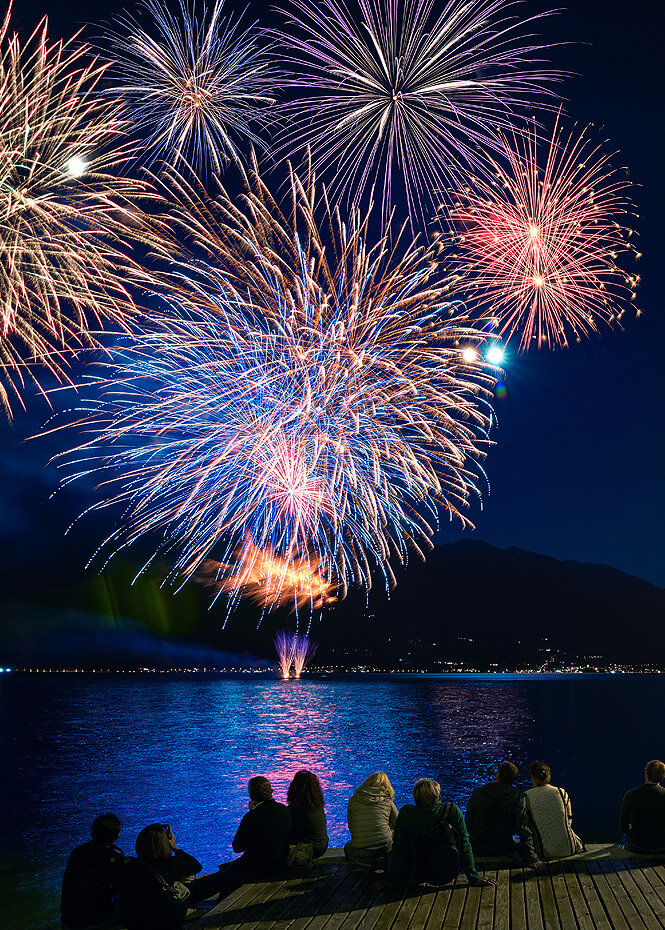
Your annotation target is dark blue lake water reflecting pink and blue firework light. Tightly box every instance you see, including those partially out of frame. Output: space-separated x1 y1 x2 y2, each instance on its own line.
0 674 665 930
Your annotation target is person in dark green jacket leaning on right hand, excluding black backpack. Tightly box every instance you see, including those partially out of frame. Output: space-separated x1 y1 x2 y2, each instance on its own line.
386 778 496 885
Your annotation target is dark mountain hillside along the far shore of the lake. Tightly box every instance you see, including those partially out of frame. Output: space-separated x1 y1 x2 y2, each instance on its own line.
0 540 665 667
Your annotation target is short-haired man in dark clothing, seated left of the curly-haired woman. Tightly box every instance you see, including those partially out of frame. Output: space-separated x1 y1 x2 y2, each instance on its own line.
219 775 291 899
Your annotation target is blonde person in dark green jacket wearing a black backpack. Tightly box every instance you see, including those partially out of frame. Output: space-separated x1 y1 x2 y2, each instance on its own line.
387 778 496 885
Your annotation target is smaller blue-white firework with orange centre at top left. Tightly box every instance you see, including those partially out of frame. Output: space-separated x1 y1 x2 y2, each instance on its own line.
108 0 276 171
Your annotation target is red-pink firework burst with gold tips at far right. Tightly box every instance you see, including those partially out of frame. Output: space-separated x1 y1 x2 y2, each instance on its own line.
452 120 639 351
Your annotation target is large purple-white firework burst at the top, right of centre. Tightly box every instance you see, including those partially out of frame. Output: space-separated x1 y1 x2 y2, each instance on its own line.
278 0 557 218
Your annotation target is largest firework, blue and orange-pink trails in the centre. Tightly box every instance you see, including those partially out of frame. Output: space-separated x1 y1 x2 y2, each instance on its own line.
53 156 495 609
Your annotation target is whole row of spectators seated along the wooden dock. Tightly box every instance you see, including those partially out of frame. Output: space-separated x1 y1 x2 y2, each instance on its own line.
61 760 665 930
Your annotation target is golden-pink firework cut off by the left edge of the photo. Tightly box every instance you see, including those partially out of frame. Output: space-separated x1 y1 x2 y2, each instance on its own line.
0 0 156 413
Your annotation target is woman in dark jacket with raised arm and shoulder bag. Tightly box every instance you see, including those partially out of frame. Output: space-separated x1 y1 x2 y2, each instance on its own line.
120 823 221 930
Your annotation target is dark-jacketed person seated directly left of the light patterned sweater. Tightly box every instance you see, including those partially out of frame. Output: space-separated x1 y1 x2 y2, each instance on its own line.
465 762 546 869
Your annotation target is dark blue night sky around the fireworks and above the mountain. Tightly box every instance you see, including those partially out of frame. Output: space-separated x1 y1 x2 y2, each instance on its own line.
0 0 665 640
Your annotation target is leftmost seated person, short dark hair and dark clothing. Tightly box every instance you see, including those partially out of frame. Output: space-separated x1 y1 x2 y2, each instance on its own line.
60 814 125 930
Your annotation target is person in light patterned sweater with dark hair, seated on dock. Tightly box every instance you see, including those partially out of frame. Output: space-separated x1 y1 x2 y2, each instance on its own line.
524 762 584 859
